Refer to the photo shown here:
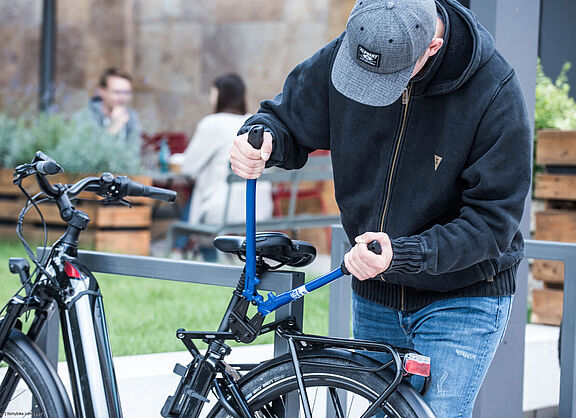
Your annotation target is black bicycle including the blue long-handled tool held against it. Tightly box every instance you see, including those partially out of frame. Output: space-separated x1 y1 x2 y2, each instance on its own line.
0 146 434 418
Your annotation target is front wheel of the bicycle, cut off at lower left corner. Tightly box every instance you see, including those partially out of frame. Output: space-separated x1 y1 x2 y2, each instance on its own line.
0 330 73 418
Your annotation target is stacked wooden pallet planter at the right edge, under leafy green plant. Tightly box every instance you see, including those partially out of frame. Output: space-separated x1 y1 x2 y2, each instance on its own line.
531 130 576 325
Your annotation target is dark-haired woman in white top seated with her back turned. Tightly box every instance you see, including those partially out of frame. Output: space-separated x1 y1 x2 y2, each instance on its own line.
181 74 273 261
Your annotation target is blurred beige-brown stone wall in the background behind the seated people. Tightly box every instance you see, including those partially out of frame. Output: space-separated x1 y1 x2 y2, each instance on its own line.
0 0 354 135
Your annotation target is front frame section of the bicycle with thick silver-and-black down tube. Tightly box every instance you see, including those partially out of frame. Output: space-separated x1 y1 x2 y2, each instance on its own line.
0 229 122 417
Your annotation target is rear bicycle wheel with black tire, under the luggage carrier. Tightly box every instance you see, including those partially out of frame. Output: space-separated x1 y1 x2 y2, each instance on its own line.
209 356 433 418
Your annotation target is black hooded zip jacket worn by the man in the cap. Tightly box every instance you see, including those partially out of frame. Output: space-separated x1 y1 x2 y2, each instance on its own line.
240 0 532 310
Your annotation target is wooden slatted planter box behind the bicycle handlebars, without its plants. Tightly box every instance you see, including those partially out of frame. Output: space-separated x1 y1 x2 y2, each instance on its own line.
0 170 152 255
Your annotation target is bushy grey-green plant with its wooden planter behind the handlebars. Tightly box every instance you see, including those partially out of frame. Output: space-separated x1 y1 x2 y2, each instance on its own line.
0 113 151 254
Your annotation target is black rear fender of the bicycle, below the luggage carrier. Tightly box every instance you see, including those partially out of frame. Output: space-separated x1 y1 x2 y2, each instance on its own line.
239 348 436 418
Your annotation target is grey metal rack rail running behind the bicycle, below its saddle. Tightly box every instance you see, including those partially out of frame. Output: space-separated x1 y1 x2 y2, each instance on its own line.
37 248 304 365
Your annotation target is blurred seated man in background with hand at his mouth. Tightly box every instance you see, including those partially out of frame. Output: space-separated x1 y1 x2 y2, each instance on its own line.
74 68 142 155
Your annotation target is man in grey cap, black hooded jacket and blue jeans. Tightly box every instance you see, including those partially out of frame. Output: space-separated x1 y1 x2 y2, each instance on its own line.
231 0 531 417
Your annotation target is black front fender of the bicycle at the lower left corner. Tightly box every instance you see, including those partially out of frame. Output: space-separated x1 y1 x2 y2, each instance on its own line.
10 329 74 418
